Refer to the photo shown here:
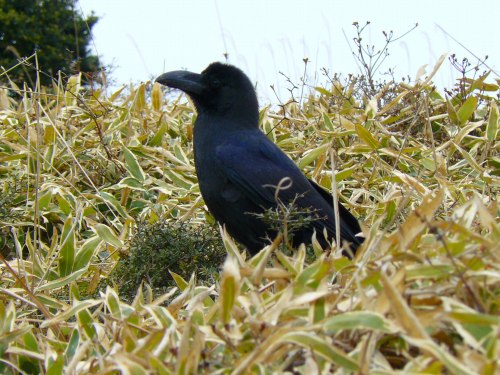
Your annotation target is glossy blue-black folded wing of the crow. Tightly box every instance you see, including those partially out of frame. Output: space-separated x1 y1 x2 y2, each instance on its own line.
216 133 363 248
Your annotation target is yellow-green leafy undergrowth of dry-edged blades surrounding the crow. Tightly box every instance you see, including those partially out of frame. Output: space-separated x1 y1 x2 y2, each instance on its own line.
0 56 500 374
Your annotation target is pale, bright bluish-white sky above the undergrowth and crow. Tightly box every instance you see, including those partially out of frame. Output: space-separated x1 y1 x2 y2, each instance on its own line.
79 0 500 102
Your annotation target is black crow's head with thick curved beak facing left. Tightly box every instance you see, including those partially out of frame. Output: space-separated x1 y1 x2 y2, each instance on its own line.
156 62 259 125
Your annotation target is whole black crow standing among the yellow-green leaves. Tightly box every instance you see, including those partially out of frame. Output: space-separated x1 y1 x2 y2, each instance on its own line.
156 62 363 254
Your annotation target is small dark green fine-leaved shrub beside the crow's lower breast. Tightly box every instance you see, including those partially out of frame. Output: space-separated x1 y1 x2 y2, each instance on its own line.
112 222 226 299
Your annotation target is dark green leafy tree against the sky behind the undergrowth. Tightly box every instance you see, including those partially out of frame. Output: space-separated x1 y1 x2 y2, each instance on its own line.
0 0 100 86
